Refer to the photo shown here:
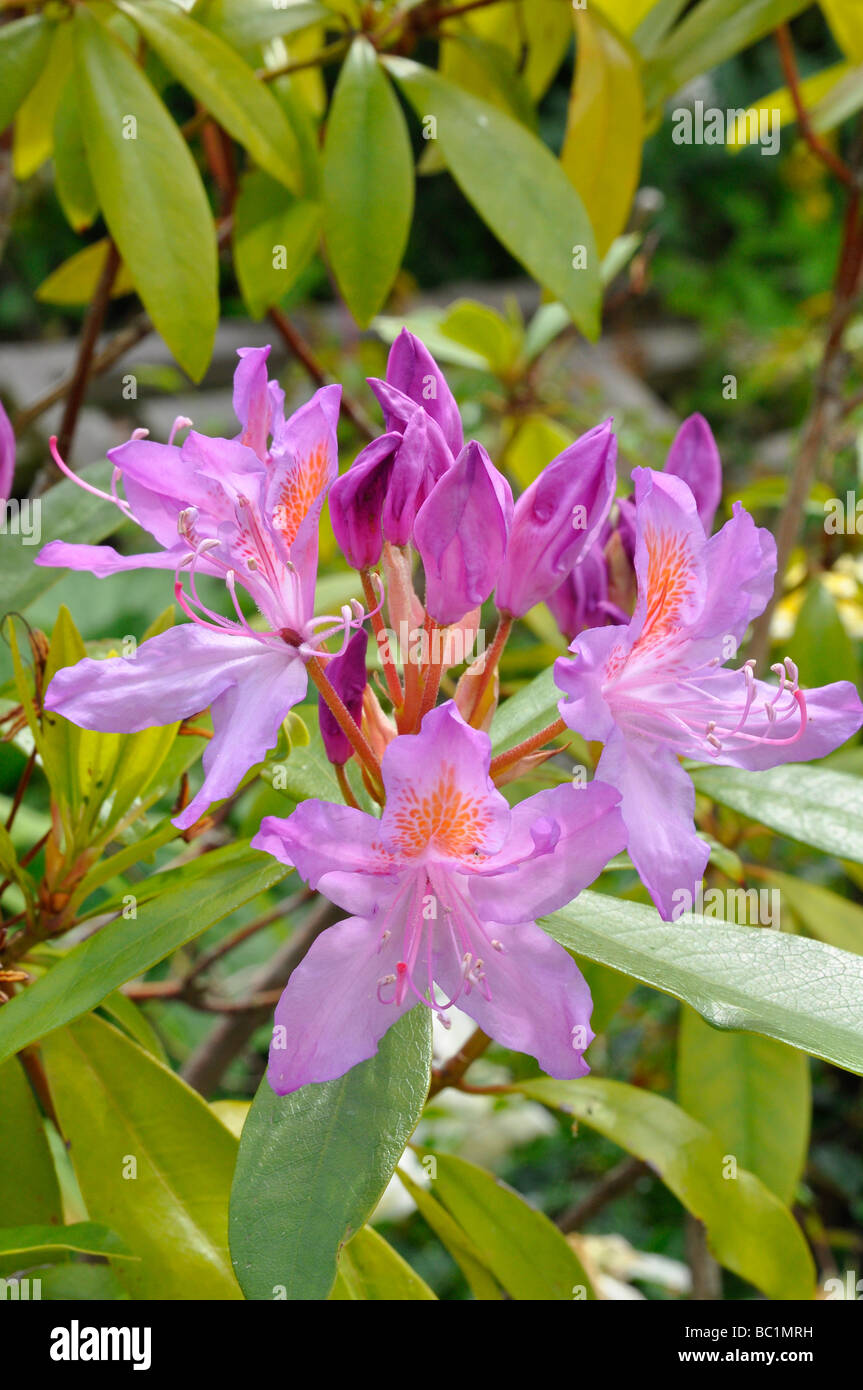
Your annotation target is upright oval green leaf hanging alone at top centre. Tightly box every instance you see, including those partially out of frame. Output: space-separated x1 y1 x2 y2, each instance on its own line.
324 38 414 328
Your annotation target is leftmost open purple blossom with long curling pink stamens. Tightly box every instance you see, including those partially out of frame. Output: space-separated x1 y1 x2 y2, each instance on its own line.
39 349 352 828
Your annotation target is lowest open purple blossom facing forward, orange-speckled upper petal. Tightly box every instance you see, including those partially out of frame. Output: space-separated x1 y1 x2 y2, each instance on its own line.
253 701 625 1095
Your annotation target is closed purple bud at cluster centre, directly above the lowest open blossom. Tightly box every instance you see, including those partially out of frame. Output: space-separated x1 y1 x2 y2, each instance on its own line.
414 441 513 627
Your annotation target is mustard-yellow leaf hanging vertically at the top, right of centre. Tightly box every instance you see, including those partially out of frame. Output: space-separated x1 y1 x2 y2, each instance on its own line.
560 10 643 256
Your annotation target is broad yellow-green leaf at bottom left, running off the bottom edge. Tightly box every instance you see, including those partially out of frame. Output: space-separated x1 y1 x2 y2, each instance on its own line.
42 1015 240 1300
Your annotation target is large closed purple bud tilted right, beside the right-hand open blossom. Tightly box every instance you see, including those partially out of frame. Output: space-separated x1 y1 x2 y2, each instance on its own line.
495 420 617 617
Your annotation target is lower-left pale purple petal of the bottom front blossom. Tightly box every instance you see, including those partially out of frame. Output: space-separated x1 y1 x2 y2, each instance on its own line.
267 917 417 1095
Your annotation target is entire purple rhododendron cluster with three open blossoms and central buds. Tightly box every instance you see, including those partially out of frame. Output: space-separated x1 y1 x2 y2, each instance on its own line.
39 331 863 1094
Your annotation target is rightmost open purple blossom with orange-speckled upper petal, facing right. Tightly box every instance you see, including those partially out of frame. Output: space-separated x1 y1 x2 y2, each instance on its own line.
554 468 863 919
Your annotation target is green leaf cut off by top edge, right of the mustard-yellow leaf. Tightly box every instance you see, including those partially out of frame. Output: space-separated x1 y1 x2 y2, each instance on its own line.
648 0 809 106
